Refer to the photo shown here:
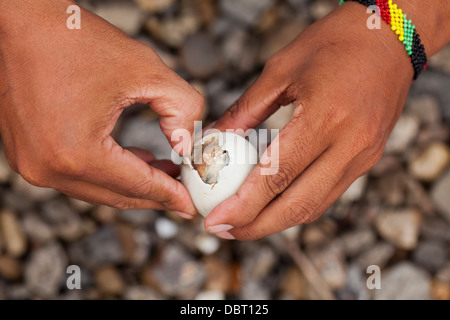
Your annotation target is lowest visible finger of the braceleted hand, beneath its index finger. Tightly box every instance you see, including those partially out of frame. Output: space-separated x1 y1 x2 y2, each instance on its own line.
227 142 380 240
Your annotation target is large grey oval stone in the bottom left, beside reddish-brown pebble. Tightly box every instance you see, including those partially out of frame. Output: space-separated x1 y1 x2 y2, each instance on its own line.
24 243 68 298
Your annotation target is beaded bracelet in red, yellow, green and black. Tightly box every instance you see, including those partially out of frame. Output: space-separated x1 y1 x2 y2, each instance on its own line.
339 0 428 80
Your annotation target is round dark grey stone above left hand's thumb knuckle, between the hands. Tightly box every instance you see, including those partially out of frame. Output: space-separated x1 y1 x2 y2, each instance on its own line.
181 33 221 78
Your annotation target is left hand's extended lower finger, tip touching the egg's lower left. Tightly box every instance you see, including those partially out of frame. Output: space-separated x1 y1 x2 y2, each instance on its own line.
83 137 196 215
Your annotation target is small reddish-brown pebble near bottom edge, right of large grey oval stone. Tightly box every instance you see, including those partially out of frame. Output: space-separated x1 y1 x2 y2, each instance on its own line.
94 266 126 297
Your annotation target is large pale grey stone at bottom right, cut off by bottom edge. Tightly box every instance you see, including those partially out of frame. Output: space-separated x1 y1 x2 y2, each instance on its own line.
374 262 432 300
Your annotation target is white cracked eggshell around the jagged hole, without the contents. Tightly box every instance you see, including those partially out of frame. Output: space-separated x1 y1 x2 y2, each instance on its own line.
181 132 258 217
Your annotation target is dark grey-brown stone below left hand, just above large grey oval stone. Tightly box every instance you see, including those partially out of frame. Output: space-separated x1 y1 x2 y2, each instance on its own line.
41 198 83 241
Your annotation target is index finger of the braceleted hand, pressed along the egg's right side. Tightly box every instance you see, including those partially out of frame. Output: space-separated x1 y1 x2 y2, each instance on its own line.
205 106 329 230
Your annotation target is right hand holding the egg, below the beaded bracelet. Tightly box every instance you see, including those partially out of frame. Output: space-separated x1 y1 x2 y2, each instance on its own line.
205 3 413 240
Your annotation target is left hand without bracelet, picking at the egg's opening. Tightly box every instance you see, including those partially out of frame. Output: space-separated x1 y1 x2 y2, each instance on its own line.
0 0 203 218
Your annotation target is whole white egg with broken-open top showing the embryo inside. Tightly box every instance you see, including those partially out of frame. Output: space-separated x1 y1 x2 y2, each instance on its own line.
181 132 258 217
